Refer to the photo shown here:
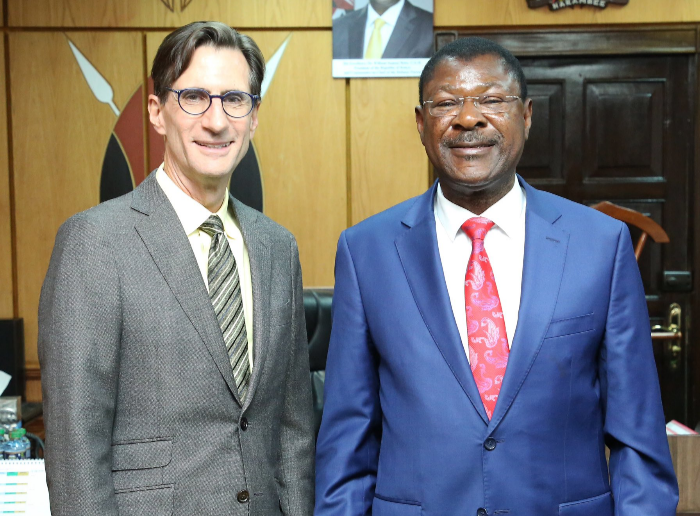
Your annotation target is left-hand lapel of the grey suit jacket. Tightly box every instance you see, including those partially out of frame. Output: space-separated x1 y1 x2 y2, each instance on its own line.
132 173 240 403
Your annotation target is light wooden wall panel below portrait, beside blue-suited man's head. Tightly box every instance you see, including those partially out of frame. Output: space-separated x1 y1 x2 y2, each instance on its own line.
349 79 429 224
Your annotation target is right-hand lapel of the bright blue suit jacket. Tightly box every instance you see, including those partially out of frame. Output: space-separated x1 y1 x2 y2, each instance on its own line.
489 178 569 430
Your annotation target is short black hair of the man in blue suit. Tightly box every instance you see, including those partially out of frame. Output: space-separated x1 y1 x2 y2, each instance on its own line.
418 36 527 105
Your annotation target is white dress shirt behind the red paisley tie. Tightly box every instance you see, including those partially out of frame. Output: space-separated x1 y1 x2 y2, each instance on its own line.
434 179 526 360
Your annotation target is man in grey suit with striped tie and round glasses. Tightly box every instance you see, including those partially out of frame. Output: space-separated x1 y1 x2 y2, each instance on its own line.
39 22 314 516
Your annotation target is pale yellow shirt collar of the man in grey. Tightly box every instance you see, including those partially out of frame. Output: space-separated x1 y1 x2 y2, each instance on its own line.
156 164 240 238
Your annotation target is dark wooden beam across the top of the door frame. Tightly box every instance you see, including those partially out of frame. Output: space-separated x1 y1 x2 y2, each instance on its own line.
435 25 697 57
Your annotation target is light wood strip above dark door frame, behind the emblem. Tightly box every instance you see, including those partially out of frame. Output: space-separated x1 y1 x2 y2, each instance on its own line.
438 0 700 27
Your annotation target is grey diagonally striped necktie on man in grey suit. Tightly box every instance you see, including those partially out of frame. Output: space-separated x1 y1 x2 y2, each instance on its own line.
199 215 250 401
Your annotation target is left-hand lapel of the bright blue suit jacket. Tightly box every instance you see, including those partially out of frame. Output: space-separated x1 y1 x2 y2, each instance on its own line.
395 183 488 423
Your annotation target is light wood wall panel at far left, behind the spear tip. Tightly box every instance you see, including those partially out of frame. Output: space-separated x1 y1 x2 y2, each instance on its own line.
9 32 143 368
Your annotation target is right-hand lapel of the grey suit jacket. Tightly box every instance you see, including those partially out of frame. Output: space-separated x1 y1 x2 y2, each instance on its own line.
229 197 272 409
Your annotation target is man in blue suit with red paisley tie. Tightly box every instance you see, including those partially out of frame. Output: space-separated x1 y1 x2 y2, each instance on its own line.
315 38 678 516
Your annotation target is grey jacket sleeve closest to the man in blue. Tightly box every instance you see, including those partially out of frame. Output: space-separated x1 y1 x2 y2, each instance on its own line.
280 237 314 516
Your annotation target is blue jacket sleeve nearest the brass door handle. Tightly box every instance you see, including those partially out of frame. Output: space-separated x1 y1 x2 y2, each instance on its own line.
599 225 678 516
